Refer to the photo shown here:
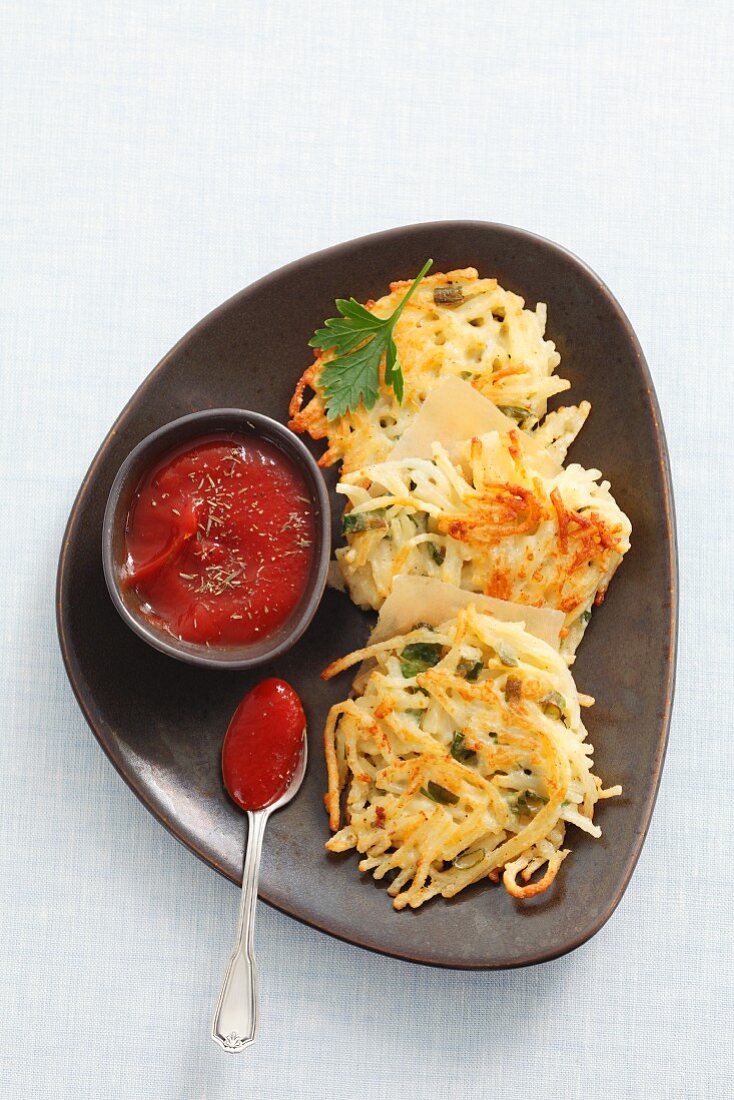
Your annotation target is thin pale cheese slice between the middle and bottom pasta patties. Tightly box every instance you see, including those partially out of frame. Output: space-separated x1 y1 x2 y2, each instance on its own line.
369 574 565 650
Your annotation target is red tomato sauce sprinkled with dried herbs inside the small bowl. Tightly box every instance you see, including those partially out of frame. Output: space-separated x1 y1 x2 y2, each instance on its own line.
122 435 316 646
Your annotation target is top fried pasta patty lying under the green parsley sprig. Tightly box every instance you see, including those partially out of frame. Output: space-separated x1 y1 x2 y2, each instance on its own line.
289 267 569 472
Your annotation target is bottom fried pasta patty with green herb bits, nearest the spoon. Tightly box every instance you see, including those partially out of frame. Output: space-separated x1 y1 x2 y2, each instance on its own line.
325 604 621 910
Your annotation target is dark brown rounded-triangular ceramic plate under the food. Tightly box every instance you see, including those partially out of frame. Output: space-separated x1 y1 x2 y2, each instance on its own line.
57 221 677 968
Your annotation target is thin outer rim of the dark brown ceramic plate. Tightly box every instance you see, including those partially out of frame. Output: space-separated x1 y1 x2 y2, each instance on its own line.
55 219 679 971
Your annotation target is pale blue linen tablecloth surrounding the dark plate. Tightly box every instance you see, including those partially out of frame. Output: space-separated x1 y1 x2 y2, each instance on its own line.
0 0 734 1100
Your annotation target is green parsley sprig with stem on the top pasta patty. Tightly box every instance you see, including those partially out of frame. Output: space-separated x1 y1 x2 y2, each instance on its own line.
308 260 434 420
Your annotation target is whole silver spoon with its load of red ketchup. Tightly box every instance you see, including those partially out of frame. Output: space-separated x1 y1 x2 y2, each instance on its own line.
211 679 307 1054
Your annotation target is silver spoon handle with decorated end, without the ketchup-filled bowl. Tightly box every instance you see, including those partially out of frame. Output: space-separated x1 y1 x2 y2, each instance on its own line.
211 810 270 1054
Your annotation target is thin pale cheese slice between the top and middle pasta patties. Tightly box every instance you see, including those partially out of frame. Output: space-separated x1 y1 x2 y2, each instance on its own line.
388 377 561 477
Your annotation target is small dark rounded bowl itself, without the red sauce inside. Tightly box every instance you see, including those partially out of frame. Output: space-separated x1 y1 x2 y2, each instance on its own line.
102 409 331 669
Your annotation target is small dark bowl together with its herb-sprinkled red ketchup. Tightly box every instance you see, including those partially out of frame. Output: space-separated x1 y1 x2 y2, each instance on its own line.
102 409 330 669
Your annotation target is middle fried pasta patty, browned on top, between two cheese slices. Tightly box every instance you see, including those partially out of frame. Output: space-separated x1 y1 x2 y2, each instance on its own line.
337 429 631 659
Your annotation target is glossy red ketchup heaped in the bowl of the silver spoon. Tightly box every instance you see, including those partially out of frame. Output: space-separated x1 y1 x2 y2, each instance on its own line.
221 680 306 810
